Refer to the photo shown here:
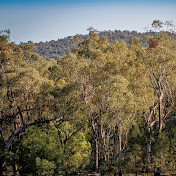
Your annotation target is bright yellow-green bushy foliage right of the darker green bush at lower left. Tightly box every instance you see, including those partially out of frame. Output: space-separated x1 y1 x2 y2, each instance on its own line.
57 122 91 172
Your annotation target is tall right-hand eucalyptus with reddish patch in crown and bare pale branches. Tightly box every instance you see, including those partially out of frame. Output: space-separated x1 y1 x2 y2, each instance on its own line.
131 20 176 170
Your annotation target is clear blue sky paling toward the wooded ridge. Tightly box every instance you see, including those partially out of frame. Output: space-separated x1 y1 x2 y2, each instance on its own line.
0 0 176 43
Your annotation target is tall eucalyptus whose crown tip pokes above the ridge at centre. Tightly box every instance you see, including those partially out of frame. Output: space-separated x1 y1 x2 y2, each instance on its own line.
59 31 108 171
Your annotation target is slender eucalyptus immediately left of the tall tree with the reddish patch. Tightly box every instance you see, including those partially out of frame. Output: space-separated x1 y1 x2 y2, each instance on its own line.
129 38 157 169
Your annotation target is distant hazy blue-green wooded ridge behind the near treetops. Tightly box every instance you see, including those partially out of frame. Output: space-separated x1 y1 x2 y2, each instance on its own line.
33 30 161 58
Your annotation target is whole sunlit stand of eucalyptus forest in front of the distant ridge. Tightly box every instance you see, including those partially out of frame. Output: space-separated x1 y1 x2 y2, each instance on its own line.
0 21 176 176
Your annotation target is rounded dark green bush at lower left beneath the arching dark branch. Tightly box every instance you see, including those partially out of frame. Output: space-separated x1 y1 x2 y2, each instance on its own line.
19 125 62 175
